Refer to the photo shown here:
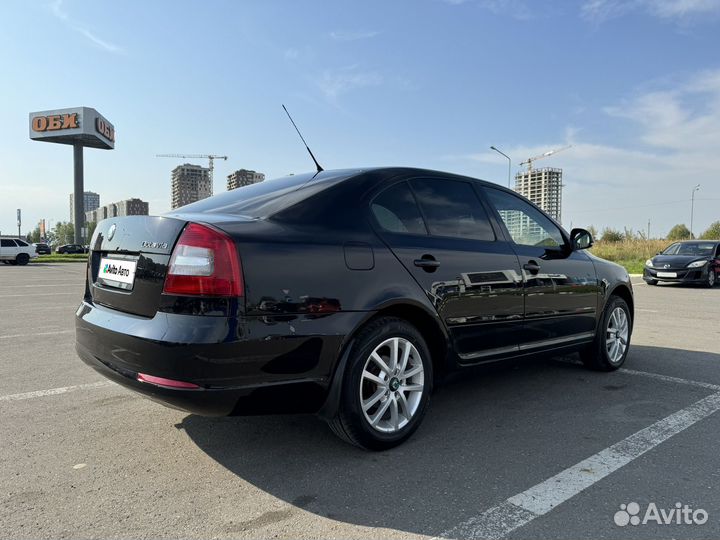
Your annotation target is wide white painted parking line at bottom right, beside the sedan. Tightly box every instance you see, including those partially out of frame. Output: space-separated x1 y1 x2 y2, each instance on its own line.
439 393 720 539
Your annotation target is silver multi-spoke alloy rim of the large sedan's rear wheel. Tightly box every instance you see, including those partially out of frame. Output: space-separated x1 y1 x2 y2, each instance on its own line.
360 337 425 433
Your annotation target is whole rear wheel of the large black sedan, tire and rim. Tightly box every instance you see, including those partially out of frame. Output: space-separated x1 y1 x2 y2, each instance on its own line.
329 317 433 450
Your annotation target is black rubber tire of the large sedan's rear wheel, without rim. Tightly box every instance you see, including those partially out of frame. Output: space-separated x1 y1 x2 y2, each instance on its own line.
328 317 433 450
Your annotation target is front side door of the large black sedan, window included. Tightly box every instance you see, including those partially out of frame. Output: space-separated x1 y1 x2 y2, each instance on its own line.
484 187 600 350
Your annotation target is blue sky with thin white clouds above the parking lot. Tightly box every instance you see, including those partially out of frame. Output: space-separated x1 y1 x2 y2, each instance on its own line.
0 0 720 236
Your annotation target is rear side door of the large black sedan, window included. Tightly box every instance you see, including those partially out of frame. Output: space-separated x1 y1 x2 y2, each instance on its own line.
370 177 523 363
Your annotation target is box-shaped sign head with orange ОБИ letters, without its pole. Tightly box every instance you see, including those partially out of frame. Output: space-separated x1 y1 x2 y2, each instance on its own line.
30 107 115 150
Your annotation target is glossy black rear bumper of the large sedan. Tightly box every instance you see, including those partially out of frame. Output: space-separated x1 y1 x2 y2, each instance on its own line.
75 302 364 416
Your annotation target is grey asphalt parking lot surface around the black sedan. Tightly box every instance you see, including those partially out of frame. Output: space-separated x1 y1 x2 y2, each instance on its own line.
0 264 720 539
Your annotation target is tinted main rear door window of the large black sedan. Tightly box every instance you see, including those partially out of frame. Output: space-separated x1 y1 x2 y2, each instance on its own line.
412 178 495 241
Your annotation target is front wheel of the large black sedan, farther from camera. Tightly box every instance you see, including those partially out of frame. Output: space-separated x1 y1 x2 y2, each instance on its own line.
580 296 632 371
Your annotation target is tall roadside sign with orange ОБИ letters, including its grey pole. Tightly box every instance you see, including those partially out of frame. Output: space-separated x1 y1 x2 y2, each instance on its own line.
28 107 115 244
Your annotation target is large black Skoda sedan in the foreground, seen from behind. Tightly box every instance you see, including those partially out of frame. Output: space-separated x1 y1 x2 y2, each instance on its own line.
76 168 633 449
